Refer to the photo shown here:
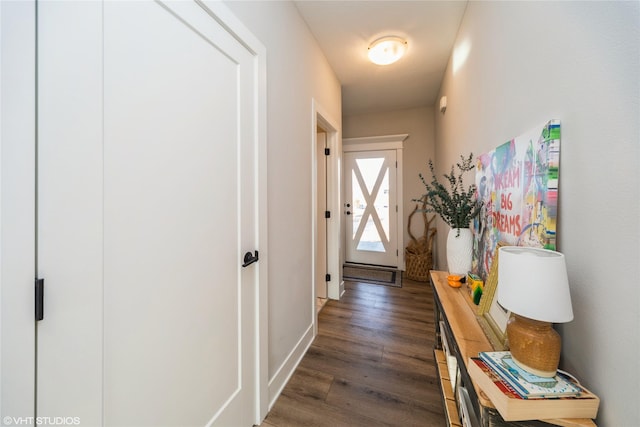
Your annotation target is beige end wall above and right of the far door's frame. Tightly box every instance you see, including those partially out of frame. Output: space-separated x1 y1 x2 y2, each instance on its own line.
342 107 435 260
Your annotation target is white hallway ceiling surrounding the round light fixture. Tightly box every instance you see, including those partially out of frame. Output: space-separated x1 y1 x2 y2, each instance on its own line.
294 0 467 116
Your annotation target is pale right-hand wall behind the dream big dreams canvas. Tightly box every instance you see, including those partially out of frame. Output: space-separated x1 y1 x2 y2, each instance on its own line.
435 2 640 426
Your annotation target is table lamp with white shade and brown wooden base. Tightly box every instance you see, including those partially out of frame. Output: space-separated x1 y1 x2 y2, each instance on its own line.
498 246 573 377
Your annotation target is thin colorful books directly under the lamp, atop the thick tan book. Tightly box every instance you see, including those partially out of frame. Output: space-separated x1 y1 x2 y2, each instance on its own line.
480 351 580 399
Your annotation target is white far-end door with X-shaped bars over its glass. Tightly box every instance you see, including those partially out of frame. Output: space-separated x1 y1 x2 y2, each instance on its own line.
344 150 398 267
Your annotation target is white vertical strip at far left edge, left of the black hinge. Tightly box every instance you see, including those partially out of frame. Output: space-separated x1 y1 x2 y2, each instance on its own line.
0 1 36 418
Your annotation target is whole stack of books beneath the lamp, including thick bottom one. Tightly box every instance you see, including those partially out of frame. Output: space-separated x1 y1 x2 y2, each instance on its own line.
468 351 600 421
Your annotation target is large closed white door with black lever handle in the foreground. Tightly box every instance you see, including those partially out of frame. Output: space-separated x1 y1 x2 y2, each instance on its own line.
36 2 259 426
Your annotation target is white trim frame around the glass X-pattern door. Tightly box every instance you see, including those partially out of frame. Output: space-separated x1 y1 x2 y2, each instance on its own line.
342 134 409 270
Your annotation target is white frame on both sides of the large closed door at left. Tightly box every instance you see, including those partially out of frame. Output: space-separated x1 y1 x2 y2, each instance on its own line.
0 0 269 425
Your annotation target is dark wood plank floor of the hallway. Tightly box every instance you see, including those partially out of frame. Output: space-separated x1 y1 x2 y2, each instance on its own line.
262 280 445 427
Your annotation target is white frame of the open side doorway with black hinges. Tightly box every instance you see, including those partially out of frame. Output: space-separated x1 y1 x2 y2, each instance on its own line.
310 99 344 310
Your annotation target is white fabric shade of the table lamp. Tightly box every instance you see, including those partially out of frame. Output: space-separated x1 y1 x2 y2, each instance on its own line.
498 246 573 323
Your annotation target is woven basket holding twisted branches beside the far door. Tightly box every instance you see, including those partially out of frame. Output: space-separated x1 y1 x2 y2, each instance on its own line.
404 205 436 282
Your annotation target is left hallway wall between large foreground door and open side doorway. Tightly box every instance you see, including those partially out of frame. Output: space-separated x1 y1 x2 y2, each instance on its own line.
226 1 341 408
